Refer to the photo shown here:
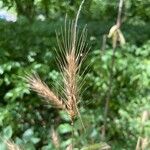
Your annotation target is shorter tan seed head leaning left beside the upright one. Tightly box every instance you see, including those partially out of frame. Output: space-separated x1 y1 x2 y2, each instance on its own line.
26 75 65 109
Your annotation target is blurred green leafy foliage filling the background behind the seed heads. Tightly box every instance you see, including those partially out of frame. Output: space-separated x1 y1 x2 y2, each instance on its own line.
0 0 150 150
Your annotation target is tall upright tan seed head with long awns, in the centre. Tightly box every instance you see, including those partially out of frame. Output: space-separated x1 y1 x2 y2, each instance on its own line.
62 0 85 122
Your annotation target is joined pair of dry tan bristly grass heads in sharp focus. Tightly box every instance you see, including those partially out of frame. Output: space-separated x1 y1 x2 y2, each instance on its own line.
26 0 88 127
